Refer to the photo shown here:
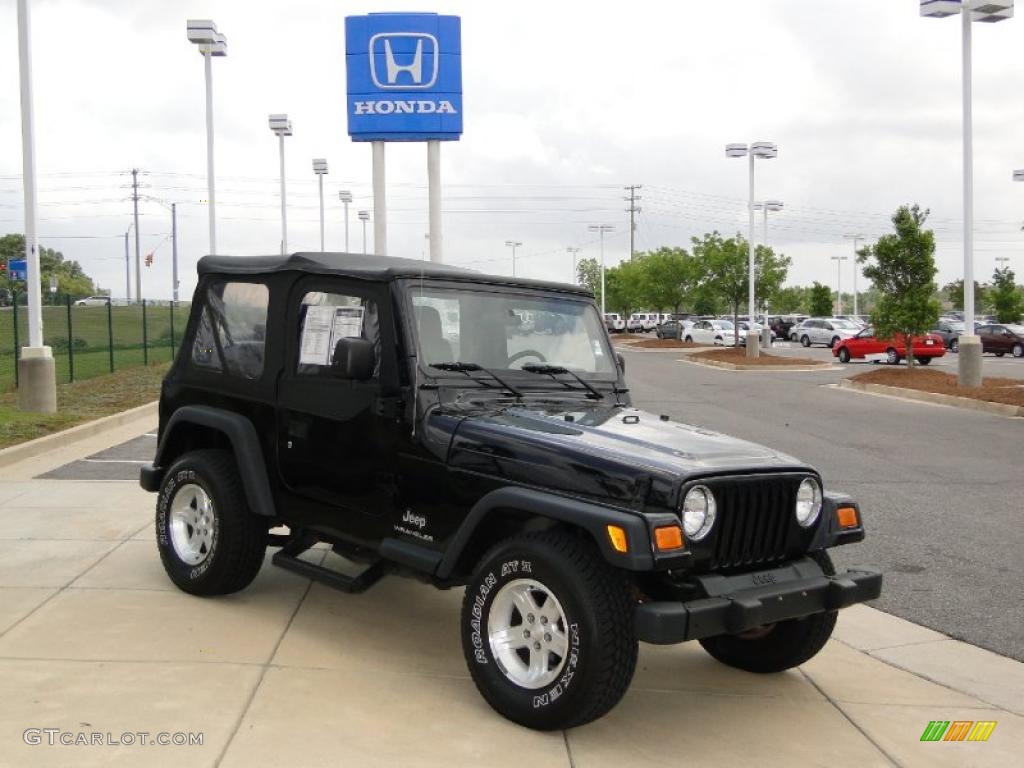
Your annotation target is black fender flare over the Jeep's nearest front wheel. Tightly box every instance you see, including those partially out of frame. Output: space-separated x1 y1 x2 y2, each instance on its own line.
436 486 654 579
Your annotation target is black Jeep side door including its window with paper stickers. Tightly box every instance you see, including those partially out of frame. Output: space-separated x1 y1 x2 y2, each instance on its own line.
278 276 399 542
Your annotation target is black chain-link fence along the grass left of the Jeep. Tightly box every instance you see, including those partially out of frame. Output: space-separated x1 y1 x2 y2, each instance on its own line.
0 296 189 392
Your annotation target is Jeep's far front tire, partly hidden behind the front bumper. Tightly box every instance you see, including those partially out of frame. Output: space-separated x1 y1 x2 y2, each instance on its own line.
699 552 838 674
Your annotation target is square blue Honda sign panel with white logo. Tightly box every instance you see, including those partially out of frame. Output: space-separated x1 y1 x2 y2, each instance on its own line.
345 13 462 141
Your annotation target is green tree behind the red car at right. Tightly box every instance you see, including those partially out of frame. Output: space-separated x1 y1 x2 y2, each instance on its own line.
857 205 939 368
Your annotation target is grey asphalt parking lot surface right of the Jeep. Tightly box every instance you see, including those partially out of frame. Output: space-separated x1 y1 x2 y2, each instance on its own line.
622 345 1024 659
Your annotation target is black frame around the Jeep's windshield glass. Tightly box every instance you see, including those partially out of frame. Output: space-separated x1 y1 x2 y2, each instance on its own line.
396 278 624 387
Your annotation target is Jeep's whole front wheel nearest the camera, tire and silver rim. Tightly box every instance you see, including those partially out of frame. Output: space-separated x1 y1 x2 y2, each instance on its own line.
461 531 638 730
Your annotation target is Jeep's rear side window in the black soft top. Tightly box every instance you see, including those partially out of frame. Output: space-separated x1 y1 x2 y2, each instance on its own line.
191 281 269 379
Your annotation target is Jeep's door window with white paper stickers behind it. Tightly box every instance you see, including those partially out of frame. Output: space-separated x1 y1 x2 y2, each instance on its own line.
296 291 381 378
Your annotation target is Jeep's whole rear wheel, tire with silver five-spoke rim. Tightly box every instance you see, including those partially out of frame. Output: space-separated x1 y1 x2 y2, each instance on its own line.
157 450 267 595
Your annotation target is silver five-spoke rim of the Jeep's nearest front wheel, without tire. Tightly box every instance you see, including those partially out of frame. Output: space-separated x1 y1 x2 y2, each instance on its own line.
487 579 568 689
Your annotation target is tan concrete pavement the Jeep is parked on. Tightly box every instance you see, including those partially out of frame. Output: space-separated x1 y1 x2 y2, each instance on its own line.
0 420 1024 768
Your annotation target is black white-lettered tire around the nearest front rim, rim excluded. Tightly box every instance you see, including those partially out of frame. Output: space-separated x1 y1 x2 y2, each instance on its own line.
460 531 638 730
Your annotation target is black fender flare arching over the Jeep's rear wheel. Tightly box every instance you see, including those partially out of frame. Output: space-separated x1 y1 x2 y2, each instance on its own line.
139 406 278 517
